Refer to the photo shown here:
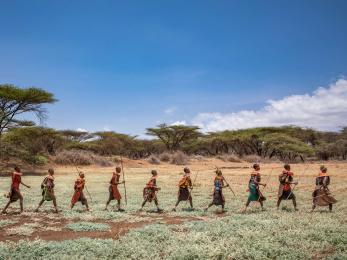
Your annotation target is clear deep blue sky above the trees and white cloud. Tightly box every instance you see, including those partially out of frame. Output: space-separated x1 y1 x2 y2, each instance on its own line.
0 0 347 135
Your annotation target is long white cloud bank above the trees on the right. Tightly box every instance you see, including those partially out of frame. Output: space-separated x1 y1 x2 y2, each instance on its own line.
192 79 347 132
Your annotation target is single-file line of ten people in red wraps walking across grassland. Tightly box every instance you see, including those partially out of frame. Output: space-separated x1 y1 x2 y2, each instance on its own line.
2 164 337 214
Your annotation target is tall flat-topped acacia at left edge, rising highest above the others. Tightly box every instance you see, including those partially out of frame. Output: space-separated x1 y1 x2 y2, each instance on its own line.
0 84 57 144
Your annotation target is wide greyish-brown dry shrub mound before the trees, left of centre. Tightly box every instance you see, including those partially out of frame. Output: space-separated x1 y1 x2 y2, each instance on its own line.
54 150 113 166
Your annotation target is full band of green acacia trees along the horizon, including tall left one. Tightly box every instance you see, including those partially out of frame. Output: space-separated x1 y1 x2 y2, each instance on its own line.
0 84 347 164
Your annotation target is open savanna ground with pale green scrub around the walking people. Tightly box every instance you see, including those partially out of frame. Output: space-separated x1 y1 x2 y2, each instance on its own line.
0 159 347 259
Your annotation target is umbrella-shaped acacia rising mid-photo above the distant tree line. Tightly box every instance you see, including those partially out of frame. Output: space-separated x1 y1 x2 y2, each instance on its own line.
146 124 201 151
